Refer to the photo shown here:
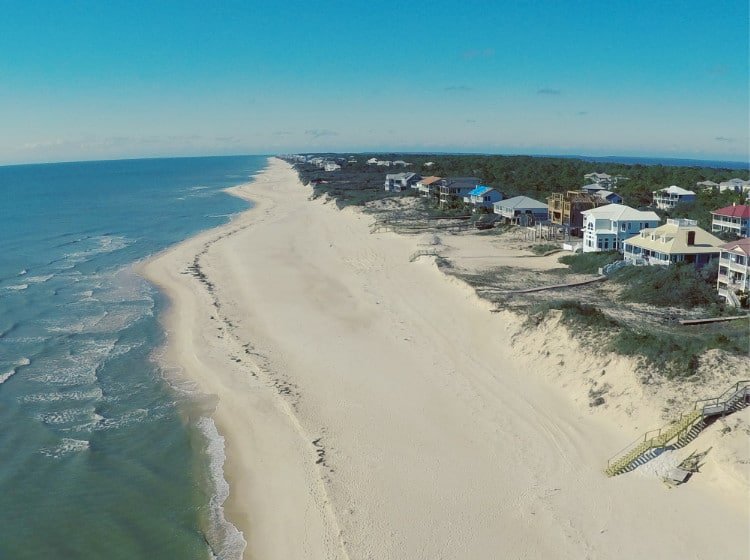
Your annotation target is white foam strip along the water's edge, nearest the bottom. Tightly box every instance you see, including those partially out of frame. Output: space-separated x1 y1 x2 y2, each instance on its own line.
197 417 247 560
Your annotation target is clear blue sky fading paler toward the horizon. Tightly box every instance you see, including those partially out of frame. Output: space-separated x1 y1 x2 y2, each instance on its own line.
0 0 750 164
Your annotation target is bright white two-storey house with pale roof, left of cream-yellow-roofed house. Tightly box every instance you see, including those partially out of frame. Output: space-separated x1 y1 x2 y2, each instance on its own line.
581 204 661 253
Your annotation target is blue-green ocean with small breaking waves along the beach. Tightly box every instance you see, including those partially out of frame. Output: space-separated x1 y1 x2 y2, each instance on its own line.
0 156 266 560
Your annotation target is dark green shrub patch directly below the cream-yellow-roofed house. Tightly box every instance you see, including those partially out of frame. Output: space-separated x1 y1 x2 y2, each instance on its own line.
612 264 719 309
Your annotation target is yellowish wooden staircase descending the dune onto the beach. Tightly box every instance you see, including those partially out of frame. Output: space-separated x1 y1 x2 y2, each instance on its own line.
605 381 750 476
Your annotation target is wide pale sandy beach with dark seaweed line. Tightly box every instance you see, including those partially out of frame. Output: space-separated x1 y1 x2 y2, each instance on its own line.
143 159 750 560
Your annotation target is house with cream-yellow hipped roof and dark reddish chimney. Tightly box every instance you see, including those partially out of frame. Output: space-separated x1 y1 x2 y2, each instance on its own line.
623 219 723 268
